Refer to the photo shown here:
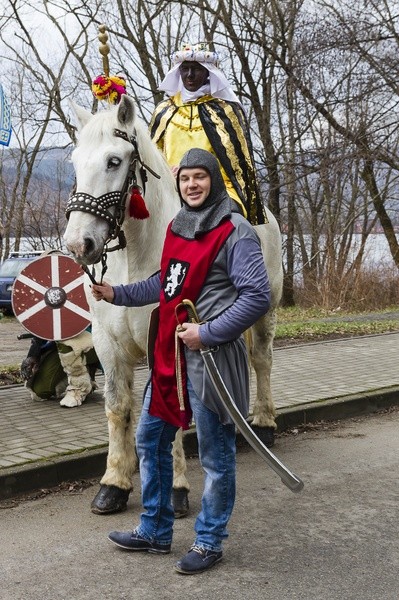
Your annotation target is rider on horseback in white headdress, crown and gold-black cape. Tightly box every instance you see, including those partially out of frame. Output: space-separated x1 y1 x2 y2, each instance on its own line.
150 44 267 225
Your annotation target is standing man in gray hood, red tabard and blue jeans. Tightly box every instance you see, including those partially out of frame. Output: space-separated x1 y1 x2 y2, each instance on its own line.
92 148 270 575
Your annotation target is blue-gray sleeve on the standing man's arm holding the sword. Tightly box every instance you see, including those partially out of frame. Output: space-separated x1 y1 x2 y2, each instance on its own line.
199 238 270 346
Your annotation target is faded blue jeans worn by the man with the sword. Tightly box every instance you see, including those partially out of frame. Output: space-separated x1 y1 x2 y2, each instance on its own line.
136 381 236 551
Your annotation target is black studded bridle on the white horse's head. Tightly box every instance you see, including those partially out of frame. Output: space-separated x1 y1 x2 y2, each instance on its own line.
65 129 160 283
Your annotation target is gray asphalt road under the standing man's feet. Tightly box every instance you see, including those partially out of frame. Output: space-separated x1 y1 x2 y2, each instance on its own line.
0 410 399 600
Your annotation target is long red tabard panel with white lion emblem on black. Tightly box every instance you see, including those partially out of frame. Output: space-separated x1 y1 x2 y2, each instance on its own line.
150 220 234 429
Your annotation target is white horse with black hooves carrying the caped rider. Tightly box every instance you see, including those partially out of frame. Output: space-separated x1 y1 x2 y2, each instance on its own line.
64 95 283 516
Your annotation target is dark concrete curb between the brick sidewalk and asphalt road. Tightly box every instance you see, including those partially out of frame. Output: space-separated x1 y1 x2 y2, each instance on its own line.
0 386 399 500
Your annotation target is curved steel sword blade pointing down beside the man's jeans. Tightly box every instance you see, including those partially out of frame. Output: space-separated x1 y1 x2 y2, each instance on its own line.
200 348 304 492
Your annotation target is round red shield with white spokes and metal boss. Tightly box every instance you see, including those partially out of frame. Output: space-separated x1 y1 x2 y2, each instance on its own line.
11 254 91 341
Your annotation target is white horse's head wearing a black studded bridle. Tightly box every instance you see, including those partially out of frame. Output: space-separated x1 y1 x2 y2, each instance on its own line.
64 95 142 265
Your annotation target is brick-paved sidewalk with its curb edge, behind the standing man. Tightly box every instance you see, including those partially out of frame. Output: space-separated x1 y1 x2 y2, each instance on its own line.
0 328 399 498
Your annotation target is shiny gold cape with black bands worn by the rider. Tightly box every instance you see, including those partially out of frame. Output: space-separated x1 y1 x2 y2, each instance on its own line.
150 92 266 225
